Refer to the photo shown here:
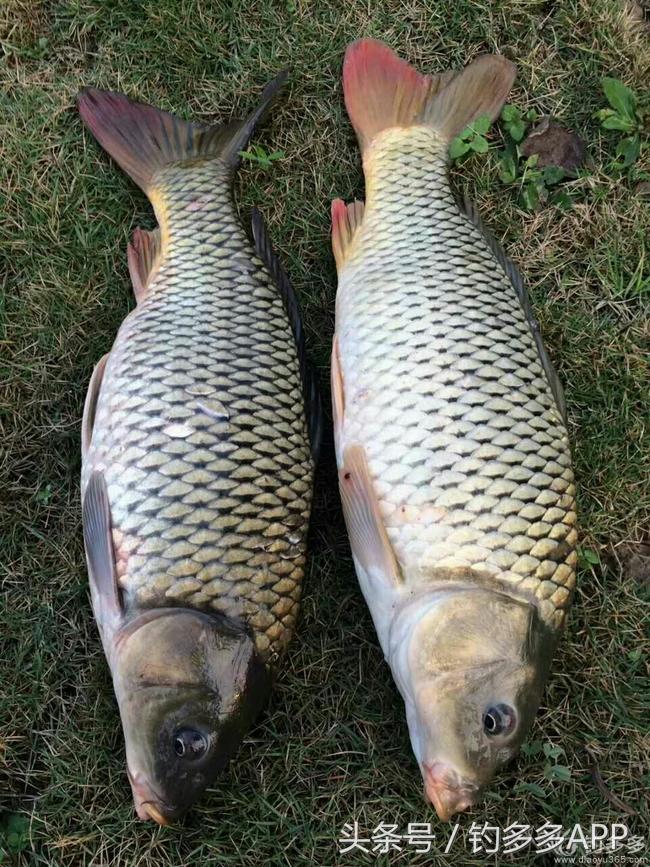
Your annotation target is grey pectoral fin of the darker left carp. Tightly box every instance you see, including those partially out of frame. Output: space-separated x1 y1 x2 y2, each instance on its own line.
82 471 123 636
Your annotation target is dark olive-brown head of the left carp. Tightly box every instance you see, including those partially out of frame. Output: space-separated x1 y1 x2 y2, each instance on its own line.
111 608 270 824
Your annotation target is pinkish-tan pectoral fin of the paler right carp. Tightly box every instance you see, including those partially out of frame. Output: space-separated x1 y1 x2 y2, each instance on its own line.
339 445 403 584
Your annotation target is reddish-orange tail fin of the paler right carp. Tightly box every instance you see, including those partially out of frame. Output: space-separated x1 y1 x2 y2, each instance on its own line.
343 39 516 152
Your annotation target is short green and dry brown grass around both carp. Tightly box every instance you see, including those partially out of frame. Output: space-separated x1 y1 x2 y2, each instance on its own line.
0 0 650 867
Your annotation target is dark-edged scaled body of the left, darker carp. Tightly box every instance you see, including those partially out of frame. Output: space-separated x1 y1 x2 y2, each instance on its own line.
82 161 313 659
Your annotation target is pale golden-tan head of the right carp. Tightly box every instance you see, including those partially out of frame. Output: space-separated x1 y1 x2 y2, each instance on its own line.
398 590 553 820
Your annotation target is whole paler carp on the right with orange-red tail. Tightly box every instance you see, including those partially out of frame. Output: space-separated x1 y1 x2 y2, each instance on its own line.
332 40 577 819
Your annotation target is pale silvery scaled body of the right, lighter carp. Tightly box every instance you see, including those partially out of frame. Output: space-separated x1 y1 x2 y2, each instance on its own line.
337 126 576 628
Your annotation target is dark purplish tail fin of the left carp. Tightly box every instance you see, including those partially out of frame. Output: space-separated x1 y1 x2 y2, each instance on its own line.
77 71 287 193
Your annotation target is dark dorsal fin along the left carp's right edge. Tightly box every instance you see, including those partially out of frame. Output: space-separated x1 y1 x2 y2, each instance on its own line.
251 208 323 460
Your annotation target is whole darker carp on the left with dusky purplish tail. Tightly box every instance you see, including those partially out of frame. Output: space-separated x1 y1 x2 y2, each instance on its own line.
78 74 320 824
